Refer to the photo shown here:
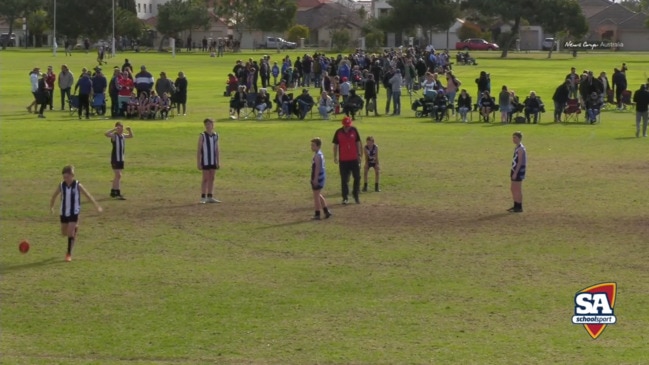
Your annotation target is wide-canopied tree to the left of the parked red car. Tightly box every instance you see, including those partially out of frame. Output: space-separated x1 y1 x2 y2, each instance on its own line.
372 0 459 41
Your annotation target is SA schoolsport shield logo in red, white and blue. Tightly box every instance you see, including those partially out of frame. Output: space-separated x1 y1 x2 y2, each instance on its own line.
572 283 617 339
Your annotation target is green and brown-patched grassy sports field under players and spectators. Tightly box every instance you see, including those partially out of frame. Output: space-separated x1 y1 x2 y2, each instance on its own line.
0 51 649 365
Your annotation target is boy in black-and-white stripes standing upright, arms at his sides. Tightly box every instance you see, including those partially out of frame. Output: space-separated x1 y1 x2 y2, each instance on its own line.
196 118 221 204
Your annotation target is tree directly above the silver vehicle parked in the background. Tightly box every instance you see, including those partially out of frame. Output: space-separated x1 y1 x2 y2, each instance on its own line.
252 0 297 33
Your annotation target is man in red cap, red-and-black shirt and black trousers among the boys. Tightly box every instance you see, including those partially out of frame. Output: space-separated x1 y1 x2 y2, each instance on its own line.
333 117 363 204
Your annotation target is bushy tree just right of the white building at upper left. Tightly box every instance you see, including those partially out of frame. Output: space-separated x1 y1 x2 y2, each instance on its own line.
157 0 210 50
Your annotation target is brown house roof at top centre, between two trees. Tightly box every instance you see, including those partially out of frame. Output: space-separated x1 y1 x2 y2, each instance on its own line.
295 2 363 29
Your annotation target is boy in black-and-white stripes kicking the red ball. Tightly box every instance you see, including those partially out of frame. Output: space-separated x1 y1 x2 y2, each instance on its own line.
50 165 102 261
